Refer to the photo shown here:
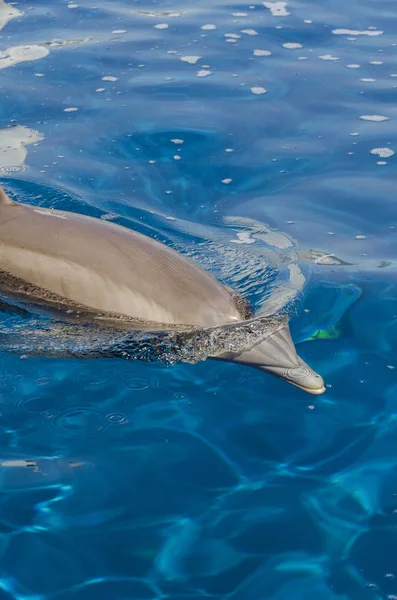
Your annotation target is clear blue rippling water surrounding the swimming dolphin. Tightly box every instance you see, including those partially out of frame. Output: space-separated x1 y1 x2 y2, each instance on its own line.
0 0 397 600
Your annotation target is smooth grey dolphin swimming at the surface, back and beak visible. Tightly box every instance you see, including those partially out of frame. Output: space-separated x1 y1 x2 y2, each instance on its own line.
0 186 325 394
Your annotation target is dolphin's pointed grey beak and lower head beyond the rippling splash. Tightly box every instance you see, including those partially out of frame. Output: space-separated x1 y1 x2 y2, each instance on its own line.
213 324 325 394
